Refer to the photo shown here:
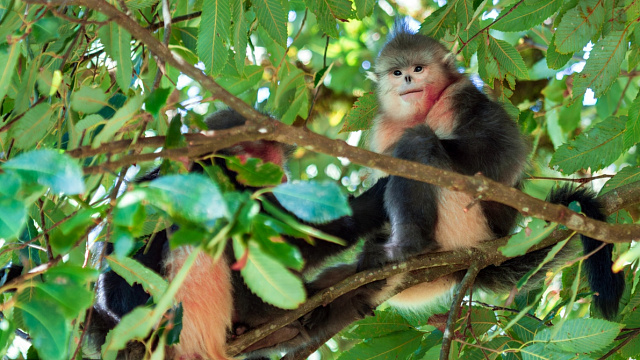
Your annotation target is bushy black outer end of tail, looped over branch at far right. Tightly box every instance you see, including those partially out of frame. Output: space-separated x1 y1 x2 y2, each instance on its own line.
549 186 624 319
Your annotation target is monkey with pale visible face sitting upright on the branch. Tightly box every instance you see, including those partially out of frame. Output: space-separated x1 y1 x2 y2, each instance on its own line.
272 25 624 354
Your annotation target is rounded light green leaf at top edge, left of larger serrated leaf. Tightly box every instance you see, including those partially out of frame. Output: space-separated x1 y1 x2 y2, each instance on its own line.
555 0 604 54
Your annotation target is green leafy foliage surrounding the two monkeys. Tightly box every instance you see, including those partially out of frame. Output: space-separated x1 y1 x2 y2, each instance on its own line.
0 0 640 360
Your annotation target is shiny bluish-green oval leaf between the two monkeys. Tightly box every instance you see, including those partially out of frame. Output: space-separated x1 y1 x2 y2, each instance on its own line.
272 182 351 223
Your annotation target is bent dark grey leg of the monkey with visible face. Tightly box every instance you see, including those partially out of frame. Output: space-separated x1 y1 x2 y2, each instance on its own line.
382 125 451 261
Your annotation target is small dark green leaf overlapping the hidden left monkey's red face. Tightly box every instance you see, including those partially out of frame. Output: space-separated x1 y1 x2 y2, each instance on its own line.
226 157 284 187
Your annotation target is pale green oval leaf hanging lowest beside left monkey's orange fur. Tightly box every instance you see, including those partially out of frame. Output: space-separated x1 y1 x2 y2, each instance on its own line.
233 239 306 309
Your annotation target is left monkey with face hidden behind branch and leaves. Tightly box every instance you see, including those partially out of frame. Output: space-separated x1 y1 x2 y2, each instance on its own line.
86 110 386 360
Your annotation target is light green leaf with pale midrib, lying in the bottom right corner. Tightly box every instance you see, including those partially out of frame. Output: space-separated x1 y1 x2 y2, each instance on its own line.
535 318 623 353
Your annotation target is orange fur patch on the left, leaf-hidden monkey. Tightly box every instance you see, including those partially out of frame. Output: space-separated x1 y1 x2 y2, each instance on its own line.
166 247 233 360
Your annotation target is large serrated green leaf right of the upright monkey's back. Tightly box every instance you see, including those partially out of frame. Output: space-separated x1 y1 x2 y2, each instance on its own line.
549 116 626 174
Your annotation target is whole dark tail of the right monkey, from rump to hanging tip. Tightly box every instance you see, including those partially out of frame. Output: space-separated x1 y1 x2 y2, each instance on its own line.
476 186 625 319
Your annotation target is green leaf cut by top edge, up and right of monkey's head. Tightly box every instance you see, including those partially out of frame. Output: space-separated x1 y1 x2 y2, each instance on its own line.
491 0 563 32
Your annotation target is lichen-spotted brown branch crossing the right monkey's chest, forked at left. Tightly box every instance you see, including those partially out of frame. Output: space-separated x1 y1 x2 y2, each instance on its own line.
27 0 640 242
